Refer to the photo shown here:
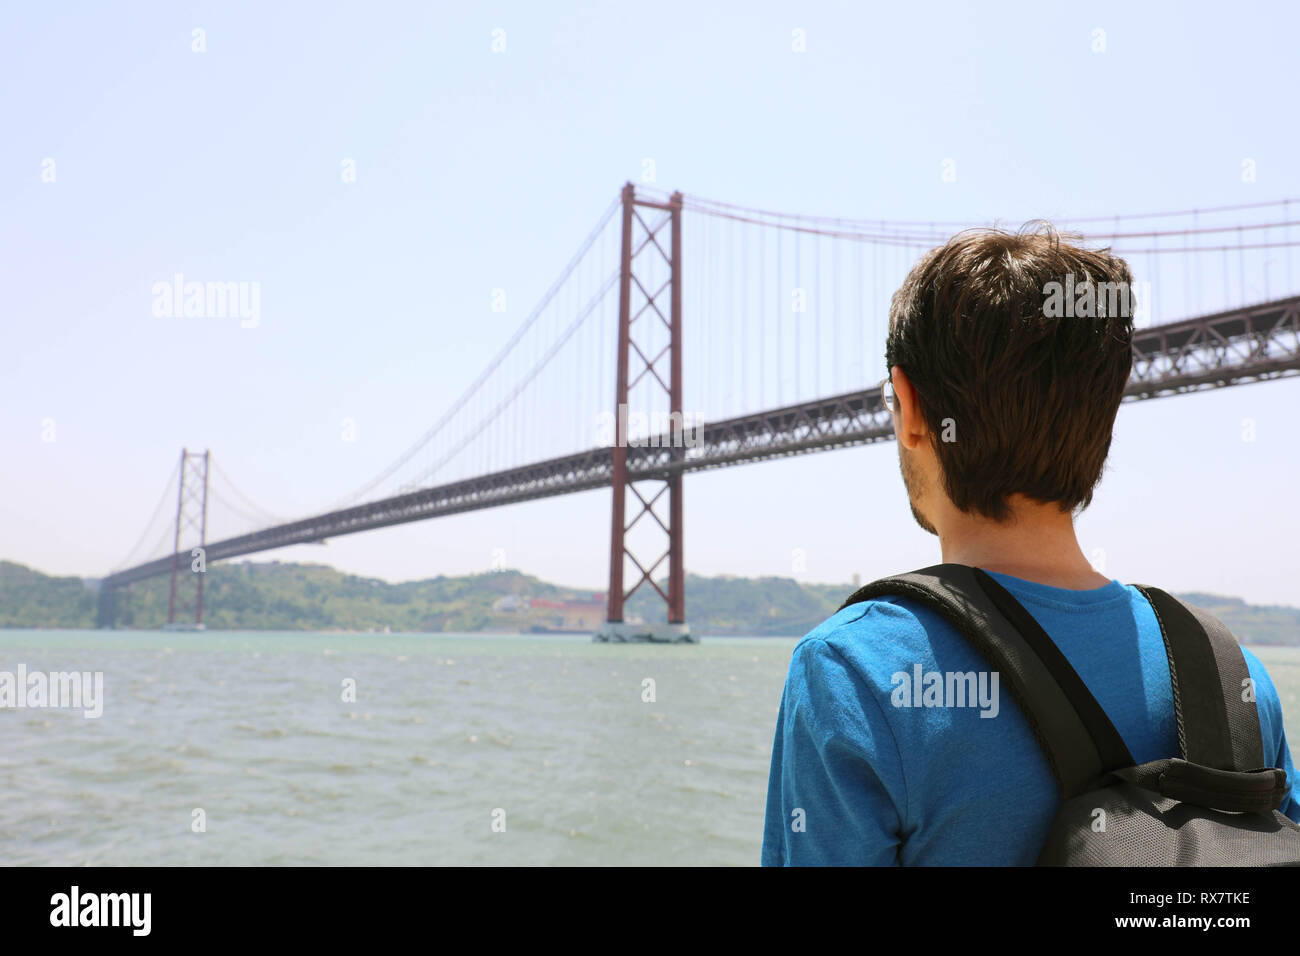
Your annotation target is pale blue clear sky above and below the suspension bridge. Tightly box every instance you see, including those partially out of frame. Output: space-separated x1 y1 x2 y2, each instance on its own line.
0 1 1300 605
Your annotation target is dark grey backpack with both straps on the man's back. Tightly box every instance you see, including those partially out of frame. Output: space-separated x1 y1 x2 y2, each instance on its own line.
841 564 1300 866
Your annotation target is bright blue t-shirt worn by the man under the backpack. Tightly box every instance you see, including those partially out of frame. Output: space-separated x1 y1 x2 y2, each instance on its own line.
762 574 1300 866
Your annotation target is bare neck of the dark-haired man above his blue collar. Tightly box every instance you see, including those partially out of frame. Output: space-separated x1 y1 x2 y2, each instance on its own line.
936 498 1110 591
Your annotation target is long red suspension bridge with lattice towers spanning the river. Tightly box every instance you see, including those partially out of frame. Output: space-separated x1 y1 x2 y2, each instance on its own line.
99 183 1300 640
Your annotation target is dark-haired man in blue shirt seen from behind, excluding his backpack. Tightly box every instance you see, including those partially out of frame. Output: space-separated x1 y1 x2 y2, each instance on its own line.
762 226 1300 866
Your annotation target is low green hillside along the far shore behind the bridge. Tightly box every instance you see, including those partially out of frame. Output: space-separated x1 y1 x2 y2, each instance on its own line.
0 561 1300 645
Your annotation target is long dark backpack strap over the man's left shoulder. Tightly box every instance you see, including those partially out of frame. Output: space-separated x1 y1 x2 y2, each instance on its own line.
840 564 1134 800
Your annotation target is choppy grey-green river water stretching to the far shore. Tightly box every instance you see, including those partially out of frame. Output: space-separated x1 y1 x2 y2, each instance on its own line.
0 631 1300 865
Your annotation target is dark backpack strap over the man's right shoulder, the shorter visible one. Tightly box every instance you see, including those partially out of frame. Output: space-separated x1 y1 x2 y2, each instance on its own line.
1134 584 1268 773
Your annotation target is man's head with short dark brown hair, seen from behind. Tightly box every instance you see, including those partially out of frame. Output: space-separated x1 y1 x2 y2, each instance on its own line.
885 224 1135 533
